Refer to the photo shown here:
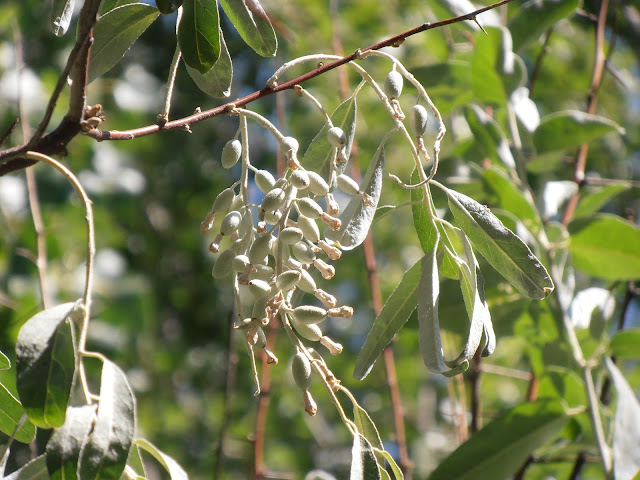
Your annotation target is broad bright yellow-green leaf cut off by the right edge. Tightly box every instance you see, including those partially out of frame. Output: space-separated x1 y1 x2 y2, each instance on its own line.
567 214 640 280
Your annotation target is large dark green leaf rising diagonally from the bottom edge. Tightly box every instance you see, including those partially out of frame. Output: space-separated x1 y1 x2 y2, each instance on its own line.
428 400 569 480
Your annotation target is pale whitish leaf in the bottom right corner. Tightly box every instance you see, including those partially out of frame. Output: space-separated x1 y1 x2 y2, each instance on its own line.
605 358 640 478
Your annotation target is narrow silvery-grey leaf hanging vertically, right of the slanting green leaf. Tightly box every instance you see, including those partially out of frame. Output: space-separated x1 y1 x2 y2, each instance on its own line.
417 249 449 373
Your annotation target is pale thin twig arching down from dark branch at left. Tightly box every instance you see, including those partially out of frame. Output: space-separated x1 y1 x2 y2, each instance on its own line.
24 152 96 403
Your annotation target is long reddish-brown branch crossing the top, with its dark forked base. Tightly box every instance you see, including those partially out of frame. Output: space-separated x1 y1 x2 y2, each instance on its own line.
0 0 513 175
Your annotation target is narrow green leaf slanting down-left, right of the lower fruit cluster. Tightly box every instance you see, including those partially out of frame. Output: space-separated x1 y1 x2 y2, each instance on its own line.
353 256 422 380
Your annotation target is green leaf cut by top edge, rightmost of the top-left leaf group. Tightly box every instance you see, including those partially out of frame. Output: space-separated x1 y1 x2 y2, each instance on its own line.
220 0 278 57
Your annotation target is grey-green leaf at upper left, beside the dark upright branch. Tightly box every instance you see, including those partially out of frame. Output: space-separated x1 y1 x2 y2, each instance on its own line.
88 3 160 82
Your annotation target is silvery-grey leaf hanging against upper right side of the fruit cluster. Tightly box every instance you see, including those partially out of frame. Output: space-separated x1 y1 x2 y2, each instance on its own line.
325 143 384 250
